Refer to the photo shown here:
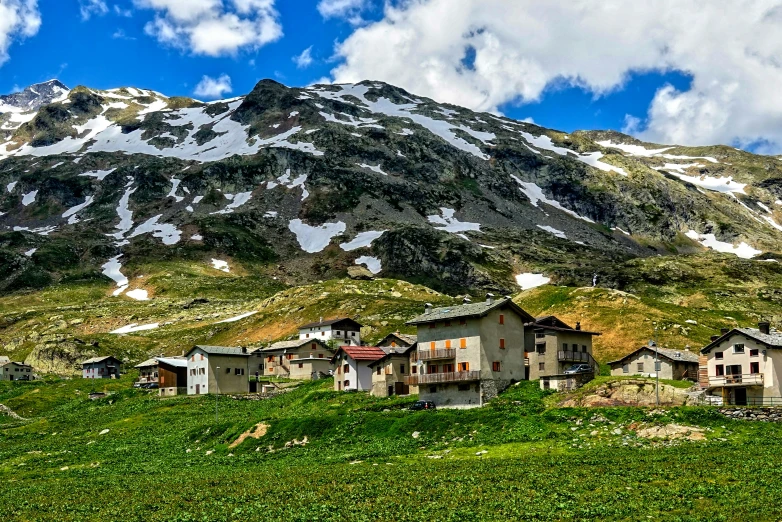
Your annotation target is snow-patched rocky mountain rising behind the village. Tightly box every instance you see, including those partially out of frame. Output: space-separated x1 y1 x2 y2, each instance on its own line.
0 76 782 370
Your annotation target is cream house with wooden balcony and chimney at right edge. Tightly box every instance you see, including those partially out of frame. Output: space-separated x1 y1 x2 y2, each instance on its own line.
699 322 782 405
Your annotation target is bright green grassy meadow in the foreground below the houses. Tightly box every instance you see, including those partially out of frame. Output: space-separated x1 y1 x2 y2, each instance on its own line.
0 376 782 521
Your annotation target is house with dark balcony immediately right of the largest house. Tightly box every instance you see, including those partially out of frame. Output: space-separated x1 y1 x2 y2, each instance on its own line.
524 315 600 389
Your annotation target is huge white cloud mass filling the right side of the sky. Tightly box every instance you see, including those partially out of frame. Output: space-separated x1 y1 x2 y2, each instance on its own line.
331 0 782 150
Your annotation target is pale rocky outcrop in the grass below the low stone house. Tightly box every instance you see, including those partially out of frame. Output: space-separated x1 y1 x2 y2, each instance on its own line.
562 379 697 408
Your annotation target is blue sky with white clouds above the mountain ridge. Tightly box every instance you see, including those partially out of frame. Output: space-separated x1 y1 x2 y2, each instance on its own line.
0 0 782 154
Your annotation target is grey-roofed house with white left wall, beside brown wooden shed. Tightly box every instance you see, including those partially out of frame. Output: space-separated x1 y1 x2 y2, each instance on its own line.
186 345 250 395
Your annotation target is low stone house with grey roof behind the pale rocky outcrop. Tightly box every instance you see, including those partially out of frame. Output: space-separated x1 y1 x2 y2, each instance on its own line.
608 342 698 381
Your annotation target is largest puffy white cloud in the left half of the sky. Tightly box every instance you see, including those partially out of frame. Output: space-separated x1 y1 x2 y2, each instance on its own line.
133 0 282 56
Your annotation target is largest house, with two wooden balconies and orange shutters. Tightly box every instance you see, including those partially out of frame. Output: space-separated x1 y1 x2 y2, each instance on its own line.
407 294 535 408
